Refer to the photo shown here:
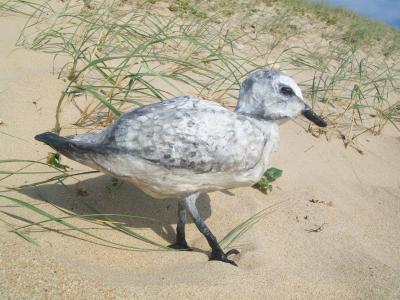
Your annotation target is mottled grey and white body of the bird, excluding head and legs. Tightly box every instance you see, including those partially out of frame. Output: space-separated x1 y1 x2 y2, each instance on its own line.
37 97 277 198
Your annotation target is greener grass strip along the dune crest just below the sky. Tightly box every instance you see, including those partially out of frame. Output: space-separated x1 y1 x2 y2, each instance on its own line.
184 0 400 57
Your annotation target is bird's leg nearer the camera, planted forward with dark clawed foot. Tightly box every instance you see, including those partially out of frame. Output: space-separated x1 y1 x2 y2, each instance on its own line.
184 193 239 266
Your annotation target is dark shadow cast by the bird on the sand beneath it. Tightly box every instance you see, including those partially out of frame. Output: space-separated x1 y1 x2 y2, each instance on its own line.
19 175 211 243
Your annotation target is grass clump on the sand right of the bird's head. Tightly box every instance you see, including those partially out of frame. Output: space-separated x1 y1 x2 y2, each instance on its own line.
291 42 400 146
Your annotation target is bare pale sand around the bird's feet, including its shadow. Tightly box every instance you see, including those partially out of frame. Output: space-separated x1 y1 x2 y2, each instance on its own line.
0 18 400 299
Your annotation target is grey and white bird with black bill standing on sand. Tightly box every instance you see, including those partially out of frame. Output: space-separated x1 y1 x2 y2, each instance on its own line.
35 69 327 266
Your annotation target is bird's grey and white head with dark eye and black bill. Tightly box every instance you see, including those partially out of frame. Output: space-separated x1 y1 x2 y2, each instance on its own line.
236 70 327 127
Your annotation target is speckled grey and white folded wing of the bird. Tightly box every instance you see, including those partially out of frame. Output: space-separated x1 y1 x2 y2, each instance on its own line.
96 97 267 173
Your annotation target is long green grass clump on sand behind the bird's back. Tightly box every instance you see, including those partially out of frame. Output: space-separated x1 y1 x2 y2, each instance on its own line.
18 1 247 132
